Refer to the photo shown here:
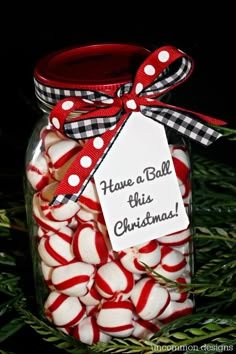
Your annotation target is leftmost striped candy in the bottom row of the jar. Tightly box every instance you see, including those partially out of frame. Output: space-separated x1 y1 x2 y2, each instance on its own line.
44 291 85 327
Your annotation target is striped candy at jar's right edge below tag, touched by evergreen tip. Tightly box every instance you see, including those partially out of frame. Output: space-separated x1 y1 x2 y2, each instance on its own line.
154 246 187 280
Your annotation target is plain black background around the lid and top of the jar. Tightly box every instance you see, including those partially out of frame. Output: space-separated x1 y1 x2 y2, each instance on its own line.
0 5 236 353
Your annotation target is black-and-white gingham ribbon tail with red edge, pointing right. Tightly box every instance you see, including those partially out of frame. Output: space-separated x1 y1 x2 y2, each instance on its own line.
141 101 226 146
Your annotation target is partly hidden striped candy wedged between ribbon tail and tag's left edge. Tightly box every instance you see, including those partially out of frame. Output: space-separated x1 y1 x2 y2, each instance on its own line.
78 179 102 213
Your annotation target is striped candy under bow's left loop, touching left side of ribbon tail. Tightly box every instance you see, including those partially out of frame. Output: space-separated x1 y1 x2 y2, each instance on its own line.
46 139 81 181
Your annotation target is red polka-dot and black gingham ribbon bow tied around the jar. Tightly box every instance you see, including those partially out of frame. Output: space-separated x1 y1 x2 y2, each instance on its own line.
50 46 226 206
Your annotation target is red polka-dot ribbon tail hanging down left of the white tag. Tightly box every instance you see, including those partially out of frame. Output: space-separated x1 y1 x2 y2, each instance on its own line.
50 114 130 206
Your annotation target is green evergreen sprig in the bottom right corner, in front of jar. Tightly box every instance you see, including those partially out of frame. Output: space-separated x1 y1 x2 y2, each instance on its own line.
92 314 236 354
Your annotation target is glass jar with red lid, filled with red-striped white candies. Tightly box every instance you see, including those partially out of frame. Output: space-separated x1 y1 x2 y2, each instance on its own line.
25 43 194 344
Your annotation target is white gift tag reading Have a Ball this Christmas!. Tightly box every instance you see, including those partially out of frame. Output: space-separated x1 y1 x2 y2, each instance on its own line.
94 112 189 251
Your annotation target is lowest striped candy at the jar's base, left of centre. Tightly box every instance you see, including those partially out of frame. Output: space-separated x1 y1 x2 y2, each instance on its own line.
71 316 111 345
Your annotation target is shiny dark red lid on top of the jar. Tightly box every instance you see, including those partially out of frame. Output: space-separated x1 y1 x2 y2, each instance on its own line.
34 43 150 104
